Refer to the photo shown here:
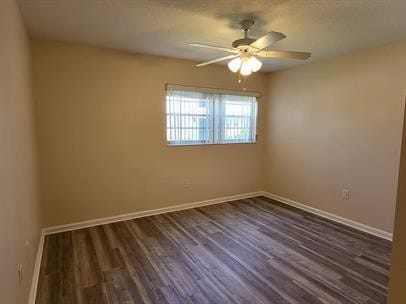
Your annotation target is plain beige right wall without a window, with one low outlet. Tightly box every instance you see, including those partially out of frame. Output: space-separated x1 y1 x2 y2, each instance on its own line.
264 43 406 233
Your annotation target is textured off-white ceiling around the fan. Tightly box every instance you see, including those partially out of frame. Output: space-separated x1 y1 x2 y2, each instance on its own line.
19 0 406 71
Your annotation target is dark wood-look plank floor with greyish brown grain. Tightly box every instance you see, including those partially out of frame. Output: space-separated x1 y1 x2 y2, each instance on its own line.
36 197 391 304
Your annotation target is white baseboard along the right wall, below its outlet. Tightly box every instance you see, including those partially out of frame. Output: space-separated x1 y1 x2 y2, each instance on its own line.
262 191 393 241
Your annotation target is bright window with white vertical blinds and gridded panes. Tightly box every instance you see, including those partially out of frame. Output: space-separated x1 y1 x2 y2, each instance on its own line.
166 87 257 145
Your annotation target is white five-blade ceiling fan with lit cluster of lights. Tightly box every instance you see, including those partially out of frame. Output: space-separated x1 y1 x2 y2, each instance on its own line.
189 19 311 76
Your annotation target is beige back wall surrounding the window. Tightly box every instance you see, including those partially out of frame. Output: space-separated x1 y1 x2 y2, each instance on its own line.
32 40 267 226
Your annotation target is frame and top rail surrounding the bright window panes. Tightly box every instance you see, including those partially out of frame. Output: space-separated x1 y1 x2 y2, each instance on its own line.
164 84 260 147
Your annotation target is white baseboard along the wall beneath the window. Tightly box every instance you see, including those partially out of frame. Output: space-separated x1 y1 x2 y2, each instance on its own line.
43 191 262 235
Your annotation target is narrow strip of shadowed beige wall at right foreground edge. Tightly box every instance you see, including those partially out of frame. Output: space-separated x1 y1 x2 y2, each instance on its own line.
388 104 406 304
